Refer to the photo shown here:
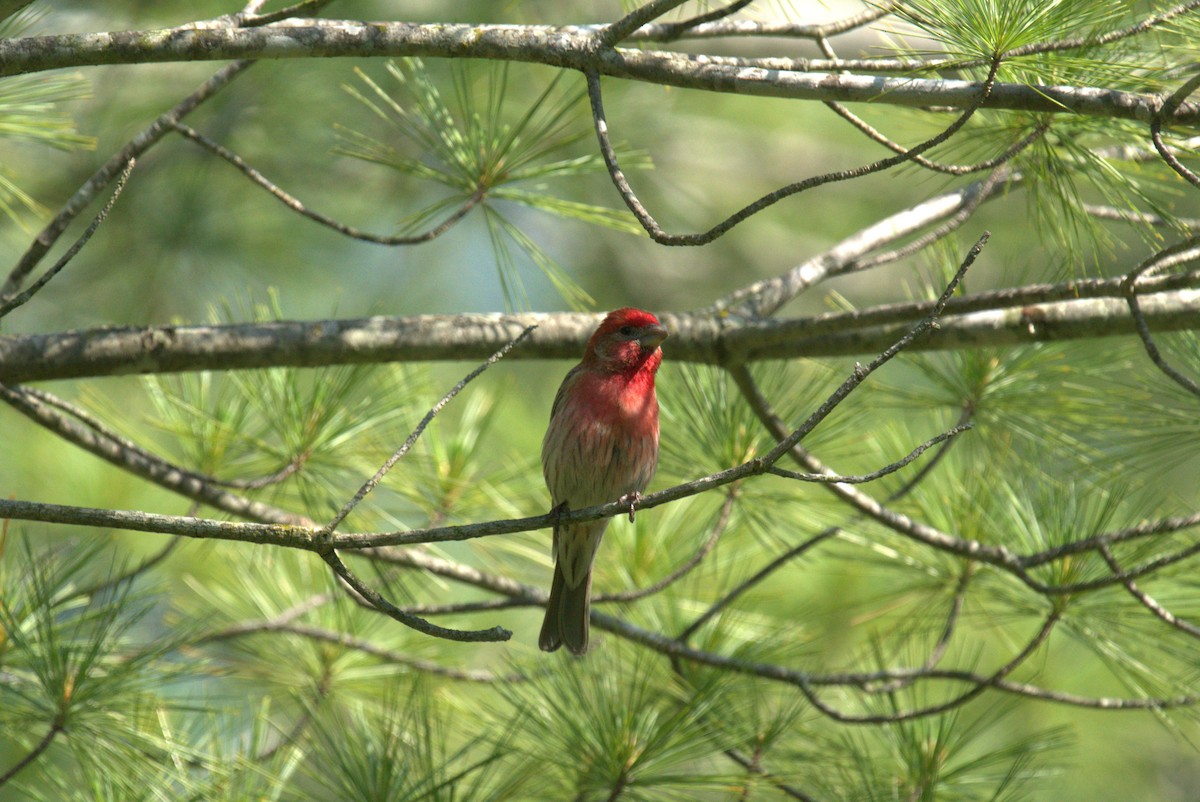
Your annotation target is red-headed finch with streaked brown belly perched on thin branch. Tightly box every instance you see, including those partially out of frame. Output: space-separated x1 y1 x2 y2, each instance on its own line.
538 309 667 654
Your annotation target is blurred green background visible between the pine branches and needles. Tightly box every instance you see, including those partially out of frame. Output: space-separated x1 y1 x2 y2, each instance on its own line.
0 0 1200 801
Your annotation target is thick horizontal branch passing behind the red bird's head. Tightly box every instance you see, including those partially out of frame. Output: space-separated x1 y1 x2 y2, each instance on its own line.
0 282 1200 383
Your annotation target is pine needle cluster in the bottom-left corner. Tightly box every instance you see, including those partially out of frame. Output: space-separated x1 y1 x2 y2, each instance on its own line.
0 538 198 798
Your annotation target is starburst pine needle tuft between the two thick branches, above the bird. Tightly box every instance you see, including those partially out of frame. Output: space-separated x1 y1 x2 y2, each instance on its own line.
338 59 649 309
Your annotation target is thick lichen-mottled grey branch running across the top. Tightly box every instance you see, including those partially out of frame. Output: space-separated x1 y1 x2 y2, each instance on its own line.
0 20 1200 125
